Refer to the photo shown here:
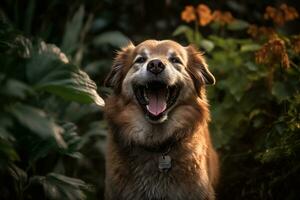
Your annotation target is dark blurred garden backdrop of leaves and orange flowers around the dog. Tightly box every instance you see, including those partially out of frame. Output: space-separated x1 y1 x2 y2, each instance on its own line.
0 0 300 200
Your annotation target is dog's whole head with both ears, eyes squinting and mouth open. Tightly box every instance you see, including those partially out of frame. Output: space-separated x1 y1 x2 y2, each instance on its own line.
106 40 215 124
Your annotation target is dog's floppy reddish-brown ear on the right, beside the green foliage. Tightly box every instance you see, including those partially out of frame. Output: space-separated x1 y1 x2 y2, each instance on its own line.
186 46 216 94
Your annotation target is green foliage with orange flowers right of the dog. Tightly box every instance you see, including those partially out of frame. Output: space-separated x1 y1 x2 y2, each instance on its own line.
174 4 300 199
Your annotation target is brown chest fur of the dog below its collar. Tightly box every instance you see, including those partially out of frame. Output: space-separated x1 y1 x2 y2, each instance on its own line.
106 133 213 200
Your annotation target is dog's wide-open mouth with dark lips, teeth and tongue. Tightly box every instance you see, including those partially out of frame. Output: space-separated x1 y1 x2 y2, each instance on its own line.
134 81 180 121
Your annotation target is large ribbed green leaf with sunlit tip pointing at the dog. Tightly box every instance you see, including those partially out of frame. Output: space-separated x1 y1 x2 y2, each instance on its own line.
26 45 104 106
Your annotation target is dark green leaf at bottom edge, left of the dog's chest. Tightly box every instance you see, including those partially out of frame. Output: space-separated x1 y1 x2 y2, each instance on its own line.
30 173 92 200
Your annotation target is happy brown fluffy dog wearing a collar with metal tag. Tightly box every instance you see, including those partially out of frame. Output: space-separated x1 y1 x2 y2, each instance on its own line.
104 40 219 200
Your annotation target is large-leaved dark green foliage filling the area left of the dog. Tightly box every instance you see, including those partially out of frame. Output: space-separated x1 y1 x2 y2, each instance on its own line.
0 16 104 199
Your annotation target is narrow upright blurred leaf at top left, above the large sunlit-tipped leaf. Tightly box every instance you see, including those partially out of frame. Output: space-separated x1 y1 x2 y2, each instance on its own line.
61 5 84 54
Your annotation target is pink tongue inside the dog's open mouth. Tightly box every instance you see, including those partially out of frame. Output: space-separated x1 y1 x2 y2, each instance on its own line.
147 90 167 116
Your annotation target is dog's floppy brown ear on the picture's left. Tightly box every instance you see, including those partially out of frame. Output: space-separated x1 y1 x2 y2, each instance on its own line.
104 42 134 92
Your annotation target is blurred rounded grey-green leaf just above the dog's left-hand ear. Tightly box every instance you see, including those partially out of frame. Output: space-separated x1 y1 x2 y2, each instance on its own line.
93 31 130 47
